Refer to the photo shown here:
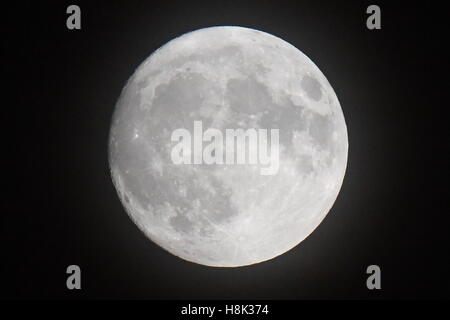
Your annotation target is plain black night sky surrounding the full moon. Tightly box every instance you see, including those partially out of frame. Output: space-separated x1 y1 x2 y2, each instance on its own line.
0 1 450 299
